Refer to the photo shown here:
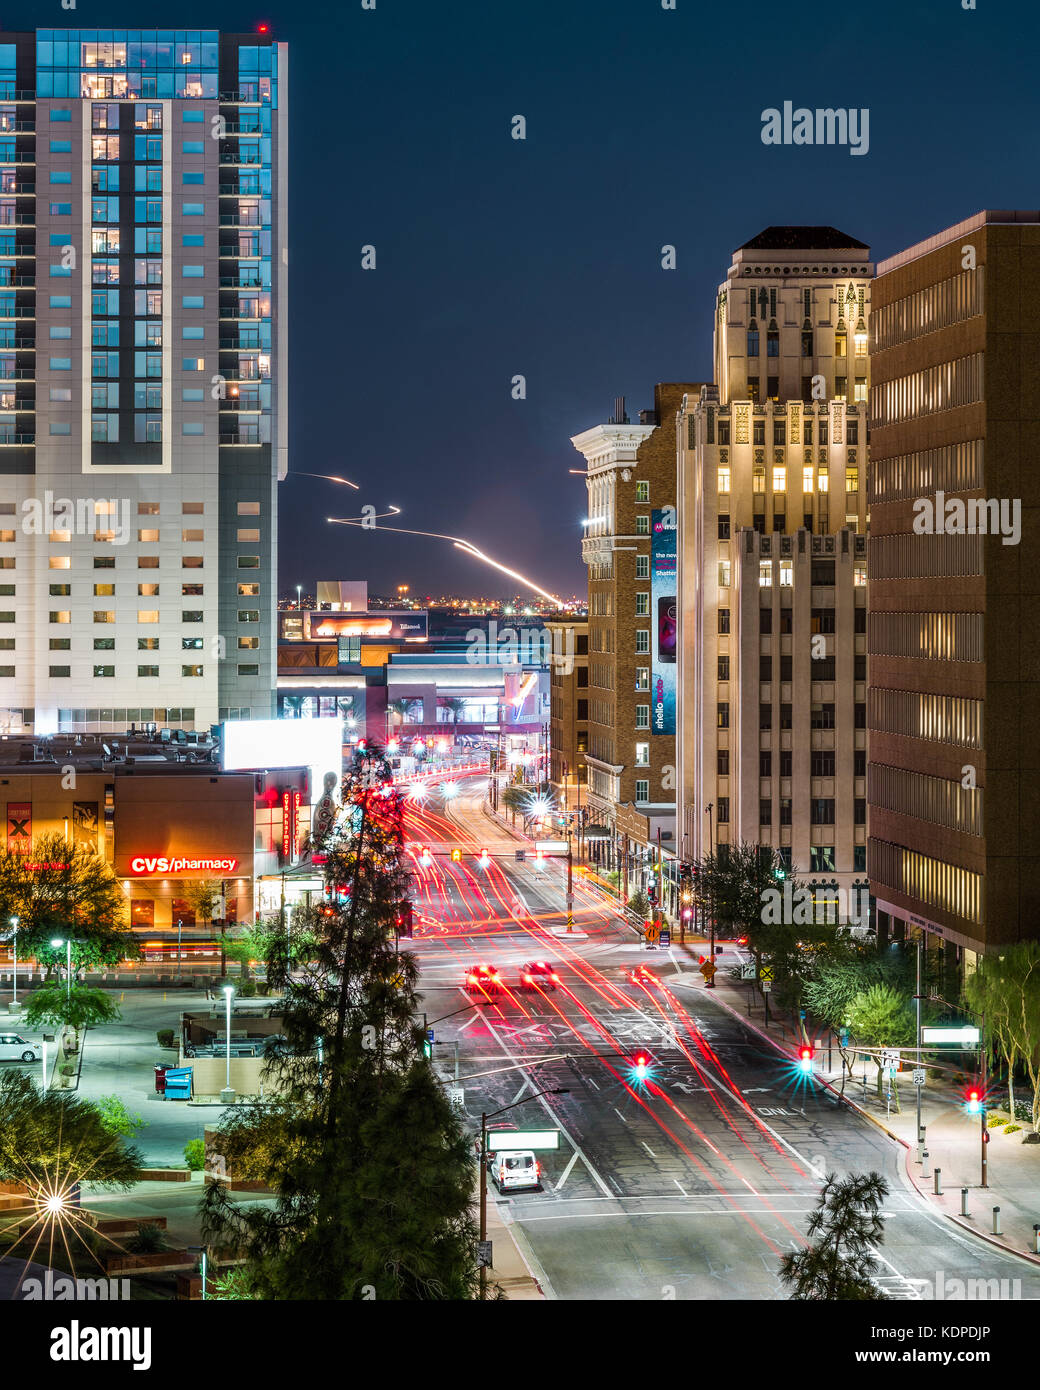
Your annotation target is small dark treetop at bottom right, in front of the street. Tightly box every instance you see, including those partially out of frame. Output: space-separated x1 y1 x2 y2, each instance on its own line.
780 1173 888 1302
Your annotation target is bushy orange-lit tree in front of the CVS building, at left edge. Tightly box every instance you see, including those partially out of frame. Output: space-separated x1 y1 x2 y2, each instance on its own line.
0 831 138 969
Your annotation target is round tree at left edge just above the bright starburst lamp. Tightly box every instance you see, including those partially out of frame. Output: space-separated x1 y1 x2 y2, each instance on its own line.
0 1072 140 1193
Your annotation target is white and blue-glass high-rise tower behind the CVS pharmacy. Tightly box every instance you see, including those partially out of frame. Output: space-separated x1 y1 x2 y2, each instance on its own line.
0 29 288 733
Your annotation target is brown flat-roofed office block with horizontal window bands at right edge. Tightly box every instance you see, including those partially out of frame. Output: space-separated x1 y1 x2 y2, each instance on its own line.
869 211 1040 956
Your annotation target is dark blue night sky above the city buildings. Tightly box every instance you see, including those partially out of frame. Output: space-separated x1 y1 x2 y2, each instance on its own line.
1 0 1040 594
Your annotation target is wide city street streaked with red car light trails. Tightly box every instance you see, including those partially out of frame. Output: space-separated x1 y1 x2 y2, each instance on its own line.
406 778 1040 1300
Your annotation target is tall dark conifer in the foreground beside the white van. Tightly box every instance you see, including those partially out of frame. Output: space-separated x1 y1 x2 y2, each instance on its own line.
202 746 477 1300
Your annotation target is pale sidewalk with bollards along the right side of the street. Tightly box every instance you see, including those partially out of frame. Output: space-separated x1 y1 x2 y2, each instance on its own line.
703 941 1040 1265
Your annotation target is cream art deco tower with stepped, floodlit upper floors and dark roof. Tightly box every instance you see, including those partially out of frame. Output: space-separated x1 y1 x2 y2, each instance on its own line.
676 227 873 898
